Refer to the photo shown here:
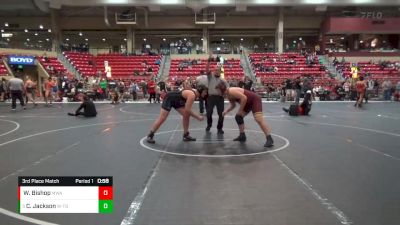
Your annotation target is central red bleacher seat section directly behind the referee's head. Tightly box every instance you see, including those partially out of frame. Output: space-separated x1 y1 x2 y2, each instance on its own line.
169 59 244 80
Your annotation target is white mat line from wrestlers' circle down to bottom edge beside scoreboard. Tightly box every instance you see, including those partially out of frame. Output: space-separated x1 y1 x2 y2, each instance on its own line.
121 123 179 225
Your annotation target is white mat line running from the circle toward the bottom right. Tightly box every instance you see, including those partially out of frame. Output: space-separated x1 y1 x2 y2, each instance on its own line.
272 154 353 225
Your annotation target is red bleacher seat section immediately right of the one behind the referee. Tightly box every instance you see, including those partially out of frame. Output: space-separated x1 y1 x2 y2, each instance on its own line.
249 53 330 85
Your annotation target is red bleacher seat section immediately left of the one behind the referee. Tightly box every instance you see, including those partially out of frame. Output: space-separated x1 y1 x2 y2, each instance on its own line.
64 52 161 80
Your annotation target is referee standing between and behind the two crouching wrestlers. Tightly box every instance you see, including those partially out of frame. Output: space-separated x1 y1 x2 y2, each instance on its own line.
200 69 229 134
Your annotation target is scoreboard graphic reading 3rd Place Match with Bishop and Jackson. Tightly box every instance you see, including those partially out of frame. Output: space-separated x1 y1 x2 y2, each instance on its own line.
18 177 113 213
